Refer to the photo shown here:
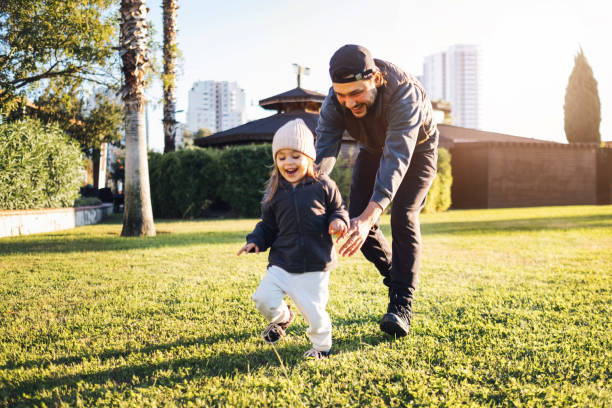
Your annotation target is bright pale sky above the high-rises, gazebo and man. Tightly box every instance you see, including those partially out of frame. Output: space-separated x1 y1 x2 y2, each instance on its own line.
142 0 612 151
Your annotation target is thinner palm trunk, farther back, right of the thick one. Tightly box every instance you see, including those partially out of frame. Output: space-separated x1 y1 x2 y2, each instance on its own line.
162 0 178 153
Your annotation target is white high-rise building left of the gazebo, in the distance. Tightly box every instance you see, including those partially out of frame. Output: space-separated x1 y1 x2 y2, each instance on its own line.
187 81 246 133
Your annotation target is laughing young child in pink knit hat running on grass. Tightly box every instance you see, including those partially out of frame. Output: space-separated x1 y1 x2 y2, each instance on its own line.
238 119 349 359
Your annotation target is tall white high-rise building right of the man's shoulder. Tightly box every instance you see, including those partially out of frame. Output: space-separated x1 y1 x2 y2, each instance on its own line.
423 44 481 129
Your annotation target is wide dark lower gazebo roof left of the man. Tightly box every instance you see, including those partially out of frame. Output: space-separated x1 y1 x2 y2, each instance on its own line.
194 111 319 147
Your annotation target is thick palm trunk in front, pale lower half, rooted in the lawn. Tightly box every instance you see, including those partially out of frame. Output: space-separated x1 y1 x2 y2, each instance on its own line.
120 0 155 237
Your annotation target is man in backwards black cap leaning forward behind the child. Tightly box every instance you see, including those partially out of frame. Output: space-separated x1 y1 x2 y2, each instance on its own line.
316 45 439 337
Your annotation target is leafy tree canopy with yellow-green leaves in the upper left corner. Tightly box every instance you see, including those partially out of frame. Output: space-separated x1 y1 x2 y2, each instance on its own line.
0 0 118 114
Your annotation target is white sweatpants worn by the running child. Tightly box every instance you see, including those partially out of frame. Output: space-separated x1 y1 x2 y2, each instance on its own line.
252 265 332 351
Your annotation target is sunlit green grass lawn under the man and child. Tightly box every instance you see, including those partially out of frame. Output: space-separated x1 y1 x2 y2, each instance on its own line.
0 206 612 407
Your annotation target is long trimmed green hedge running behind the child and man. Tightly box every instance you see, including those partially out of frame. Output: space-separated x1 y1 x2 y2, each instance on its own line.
149 144 452 218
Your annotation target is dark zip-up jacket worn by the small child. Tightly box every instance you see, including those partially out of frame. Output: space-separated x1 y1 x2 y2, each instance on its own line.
247 175 349 273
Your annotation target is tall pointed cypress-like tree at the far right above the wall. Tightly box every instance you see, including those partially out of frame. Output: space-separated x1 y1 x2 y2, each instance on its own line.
563 48 601 143
